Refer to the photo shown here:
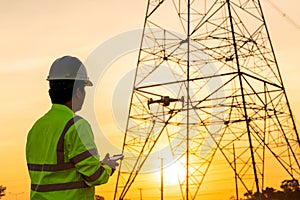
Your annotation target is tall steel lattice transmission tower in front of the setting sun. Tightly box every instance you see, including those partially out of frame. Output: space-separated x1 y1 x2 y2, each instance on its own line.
115 0 300 199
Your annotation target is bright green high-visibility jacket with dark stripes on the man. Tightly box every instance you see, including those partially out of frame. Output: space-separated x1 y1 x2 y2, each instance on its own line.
26 104 112 200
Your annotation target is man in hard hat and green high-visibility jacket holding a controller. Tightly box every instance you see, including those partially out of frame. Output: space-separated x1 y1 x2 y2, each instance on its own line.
26 56 118 200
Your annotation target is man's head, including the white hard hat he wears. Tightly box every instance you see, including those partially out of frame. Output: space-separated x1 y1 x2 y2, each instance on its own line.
47 56 93 112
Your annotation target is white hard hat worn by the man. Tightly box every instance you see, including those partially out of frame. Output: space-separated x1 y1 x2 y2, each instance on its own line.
47 56 93 86
